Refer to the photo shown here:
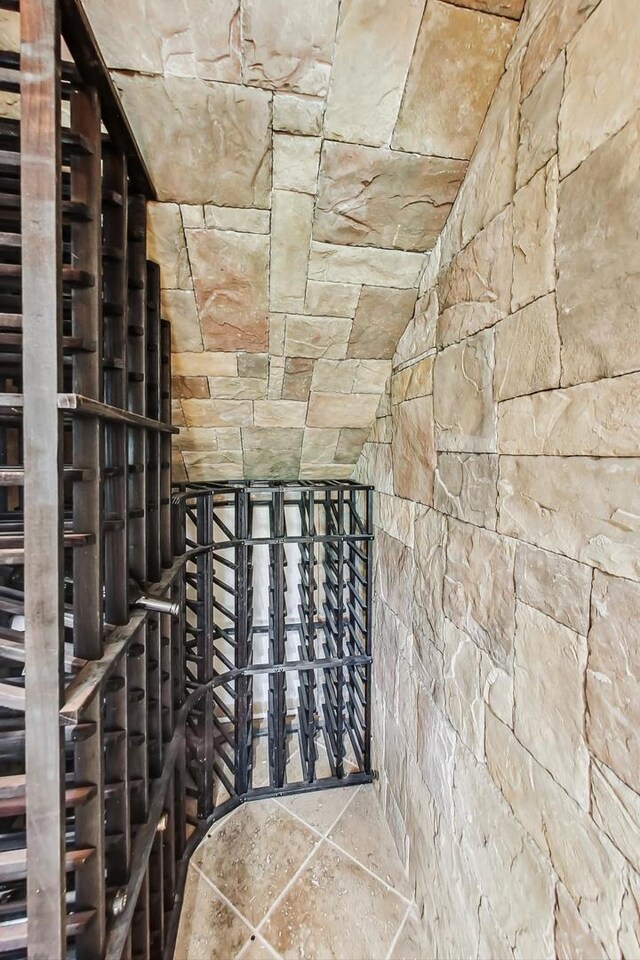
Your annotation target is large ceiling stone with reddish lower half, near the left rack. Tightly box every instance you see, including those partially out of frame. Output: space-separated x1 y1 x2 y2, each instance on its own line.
188 230 269 353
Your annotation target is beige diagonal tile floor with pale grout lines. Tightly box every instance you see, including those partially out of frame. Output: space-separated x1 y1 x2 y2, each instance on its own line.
174 785 427 960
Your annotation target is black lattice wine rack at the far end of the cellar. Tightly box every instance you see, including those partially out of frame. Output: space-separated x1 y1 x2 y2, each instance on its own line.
174 481 373 823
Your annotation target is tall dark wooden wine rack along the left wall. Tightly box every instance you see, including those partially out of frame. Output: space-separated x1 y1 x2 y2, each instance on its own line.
0 0 189 960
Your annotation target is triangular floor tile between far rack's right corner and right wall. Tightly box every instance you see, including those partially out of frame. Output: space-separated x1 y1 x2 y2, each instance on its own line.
329 784 413 899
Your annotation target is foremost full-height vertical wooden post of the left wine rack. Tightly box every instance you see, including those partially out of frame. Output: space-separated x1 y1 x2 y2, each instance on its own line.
20 0 66 960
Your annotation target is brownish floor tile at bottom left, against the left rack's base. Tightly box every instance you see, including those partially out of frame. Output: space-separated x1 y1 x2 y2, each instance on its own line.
173 868 251 960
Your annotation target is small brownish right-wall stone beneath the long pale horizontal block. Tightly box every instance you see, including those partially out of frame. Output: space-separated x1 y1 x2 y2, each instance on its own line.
515 543 592 636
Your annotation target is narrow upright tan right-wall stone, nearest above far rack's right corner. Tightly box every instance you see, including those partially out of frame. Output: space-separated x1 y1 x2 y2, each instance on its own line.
392 396 436 504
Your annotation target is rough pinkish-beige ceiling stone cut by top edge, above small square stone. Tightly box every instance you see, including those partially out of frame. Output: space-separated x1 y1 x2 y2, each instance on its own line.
242 0 338 96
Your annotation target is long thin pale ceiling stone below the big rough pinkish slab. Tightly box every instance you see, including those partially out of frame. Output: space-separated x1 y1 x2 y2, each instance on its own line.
309 240 424 289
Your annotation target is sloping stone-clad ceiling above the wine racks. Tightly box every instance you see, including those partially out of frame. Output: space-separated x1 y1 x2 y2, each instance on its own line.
85 0 524 480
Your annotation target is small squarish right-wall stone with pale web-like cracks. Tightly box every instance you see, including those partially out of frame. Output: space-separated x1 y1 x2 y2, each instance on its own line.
433 453 498 530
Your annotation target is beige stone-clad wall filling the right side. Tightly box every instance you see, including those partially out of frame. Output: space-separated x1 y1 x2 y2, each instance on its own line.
356 0 640 960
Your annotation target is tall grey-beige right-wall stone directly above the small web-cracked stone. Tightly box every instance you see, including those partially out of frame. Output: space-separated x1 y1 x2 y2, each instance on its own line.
433 330 496 453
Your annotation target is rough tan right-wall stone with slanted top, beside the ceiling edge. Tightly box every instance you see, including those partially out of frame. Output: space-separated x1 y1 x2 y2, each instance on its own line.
437 208 513 346
